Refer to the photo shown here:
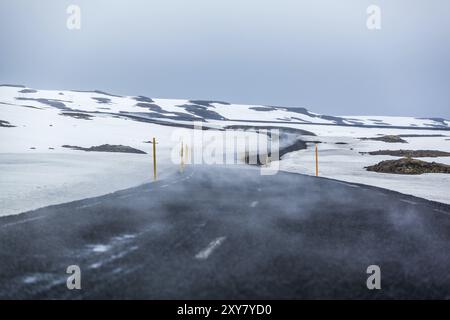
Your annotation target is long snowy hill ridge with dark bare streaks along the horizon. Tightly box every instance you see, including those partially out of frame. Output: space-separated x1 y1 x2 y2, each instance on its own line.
0 85 450 129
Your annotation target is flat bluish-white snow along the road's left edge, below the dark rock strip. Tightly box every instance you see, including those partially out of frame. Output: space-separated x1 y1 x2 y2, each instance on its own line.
0 152 152 216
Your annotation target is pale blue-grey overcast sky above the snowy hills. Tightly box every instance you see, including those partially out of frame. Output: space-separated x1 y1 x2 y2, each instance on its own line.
0 0 450 118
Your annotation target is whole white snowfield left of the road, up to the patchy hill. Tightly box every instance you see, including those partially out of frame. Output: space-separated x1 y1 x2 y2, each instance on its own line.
0 106 178 215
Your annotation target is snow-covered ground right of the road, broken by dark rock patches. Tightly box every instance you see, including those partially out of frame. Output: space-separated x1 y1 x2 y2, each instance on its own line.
280 130 450 204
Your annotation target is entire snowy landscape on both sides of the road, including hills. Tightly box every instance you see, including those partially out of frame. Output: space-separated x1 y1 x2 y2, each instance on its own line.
0 86 450 216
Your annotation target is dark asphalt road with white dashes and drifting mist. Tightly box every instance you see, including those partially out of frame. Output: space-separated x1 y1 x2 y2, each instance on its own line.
0 166 450 299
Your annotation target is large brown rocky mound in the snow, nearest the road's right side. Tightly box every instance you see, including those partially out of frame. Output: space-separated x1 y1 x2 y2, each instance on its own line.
366 158 450 174
